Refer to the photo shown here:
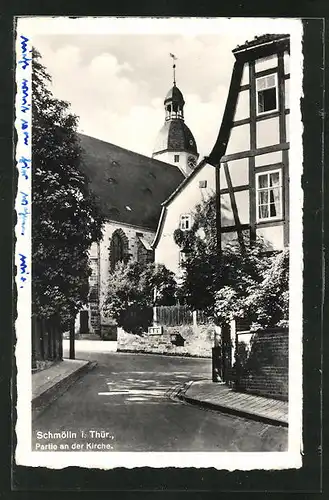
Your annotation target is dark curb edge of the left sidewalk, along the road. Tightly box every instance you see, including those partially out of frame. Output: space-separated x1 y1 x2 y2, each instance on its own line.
32 361 97 421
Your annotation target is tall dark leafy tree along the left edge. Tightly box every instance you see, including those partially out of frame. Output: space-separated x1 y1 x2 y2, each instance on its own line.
32 49 103 324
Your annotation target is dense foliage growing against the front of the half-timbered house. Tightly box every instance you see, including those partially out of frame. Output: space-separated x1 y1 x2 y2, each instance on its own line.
174 195 288 325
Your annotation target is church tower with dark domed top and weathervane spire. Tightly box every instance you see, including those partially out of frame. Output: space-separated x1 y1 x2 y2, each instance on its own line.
152 54 199 177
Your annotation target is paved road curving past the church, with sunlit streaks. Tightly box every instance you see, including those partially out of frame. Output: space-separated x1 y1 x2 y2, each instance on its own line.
33 341 287 452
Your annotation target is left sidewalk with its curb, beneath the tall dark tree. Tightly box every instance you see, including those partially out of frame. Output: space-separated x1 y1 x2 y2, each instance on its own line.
32 359 97 419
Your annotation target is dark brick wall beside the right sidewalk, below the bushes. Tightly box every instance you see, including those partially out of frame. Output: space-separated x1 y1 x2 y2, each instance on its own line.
236 329 289 401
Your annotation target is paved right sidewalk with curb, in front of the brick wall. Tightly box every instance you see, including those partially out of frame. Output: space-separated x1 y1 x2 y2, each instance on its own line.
177 380 288 427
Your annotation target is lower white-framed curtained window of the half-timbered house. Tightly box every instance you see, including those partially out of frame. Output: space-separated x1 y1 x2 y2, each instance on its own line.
256 170 282 221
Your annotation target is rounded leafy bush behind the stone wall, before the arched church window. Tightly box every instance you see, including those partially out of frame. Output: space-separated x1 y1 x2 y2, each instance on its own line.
103 262 176 334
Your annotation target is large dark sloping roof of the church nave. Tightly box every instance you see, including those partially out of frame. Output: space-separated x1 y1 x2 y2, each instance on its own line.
79 134 184 230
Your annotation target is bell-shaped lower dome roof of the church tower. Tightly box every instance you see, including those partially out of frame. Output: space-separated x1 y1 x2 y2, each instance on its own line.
154 119 198 154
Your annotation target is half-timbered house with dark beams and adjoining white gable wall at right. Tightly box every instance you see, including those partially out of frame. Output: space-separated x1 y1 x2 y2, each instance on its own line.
153 35 290 274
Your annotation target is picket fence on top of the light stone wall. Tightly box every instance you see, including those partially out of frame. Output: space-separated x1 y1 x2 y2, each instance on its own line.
154 305 210 326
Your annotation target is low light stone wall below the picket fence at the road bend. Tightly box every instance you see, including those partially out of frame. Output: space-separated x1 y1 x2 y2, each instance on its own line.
117 325 215 358
